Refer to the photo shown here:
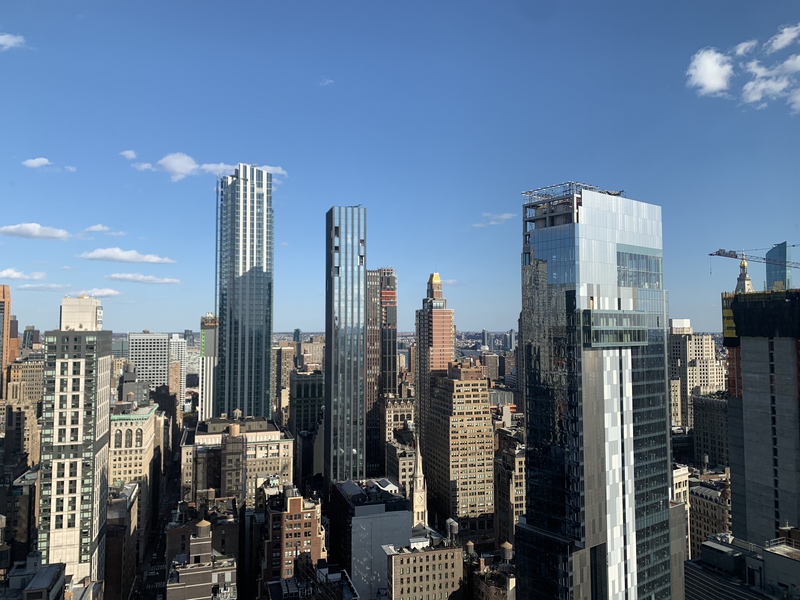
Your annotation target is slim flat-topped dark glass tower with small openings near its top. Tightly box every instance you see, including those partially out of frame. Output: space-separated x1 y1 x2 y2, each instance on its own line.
324 206 367 490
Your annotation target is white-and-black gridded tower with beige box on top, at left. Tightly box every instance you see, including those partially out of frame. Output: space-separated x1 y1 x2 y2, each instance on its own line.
39 298 112 581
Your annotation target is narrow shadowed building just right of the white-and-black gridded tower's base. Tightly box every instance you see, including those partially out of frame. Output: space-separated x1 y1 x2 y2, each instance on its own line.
103 481 143 600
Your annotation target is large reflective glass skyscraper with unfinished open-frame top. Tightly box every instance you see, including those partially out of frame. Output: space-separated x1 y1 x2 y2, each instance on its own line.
515 182 671 600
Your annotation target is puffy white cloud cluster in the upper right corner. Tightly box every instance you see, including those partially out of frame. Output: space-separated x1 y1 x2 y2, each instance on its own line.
686 23 800 112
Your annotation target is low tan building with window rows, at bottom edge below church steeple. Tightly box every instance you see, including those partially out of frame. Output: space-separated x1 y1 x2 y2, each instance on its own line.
383 536 464 600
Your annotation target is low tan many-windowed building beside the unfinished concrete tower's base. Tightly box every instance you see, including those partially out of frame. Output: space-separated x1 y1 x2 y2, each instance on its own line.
689 481 731 557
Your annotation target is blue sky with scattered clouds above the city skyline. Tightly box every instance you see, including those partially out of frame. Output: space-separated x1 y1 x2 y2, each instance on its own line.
0 0 800 331
